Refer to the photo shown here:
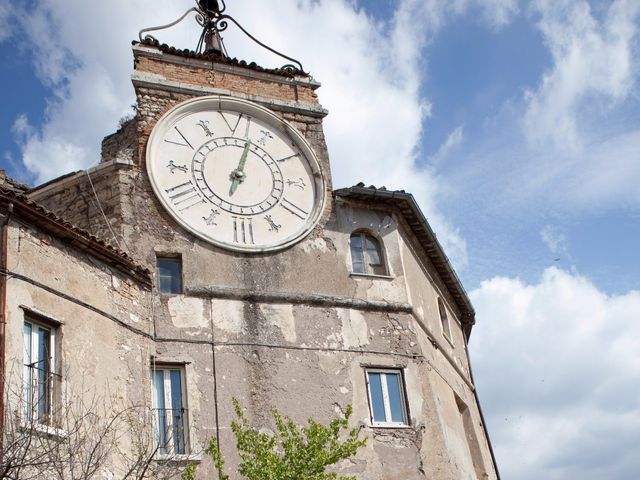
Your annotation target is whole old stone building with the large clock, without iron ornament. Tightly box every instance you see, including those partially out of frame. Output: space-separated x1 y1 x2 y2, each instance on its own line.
0 4 498 480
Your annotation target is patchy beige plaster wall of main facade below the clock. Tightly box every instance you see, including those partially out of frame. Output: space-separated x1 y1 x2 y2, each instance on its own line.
136 199 495 479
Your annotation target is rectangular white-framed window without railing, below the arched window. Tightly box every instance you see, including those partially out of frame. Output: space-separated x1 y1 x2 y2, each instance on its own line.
366 369 408 427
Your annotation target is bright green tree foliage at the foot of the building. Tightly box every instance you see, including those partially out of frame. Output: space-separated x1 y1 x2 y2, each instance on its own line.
195 399 367 480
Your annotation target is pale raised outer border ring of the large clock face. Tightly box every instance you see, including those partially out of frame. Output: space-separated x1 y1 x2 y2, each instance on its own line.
145 95 327 253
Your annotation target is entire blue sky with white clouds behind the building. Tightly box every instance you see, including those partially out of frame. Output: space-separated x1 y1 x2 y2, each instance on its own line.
0 0 640 479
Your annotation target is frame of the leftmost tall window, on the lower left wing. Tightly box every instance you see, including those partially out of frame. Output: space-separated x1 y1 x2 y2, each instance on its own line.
21 314 62 428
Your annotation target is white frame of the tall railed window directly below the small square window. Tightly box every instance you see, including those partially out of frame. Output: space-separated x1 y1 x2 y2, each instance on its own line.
151 363 191 458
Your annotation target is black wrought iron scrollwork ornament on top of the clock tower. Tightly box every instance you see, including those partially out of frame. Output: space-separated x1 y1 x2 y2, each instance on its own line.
138 0 306 74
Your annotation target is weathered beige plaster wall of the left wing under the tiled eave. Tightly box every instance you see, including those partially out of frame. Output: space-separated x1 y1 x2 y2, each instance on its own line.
3 220 153 478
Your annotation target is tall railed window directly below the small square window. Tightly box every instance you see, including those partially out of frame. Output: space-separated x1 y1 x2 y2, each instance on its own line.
152 367 188 455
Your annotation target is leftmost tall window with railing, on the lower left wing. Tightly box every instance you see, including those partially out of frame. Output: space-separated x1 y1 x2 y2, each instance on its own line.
23 319 60 425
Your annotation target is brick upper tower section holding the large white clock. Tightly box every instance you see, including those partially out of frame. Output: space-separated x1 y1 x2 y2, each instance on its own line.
127 6 331 253
